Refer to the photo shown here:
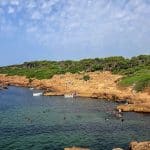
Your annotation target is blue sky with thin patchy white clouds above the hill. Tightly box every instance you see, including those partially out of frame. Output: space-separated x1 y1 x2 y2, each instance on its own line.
0 0 150 66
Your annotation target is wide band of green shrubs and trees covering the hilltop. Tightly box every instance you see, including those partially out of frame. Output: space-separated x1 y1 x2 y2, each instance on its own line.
0 55 150 91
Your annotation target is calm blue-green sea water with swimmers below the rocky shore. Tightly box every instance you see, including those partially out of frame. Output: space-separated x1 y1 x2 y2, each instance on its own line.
0 87 150 150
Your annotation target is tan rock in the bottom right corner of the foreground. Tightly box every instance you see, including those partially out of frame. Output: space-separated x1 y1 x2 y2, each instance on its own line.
130 141 150 150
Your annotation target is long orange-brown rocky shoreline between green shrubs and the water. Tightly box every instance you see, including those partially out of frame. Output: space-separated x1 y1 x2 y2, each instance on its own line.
0 71 150 112
